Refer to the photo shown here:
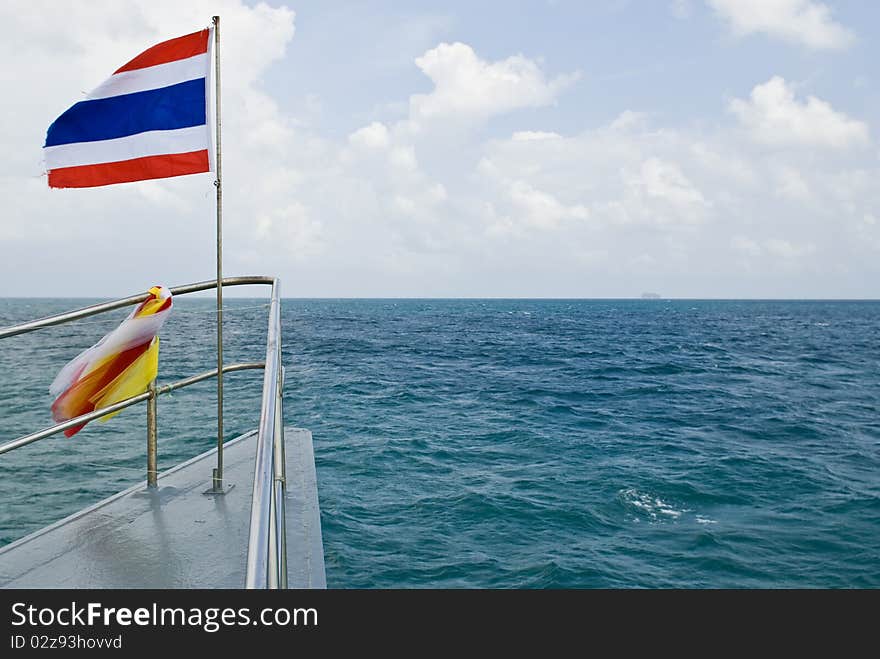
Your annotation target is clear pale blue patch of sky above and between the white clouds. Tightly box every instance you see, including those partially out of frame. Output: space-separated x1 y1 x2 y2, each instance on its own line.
274 0 880 131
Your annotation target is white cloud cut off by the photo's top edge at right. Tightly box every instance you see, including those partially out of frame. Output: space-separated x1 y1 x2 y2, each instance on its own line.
707 0 855 49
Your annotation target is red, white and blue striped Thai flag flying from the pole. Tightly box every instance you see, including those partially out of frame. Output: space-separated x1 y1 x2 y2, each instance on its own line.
43 28 214 188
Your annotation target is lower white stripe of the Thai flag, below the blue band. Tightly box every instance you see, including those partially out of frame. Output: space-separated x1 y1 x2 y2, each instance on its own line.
43 125 208 169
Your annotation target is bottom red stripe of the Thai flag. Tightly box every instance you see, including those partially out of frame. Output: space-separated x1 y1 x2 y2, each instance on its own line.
49 149 210 188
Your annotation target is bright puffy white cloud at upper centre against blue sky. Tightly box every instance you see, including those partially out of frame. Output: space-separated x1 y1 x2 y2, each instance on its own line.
410 43 577 119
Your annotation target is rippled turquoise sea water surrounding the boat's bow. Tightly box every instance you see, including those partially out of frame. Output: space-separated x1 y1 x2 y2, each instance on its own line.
0 299 880 588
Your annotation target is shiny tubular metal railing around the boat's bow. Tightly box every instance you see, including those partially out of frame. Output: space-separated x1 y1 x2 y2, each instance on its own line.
0 276 287 588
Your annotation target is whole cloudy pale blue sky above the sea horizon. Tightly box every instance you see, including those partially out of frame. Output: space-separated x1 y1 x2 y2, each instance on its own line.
0 0 880 298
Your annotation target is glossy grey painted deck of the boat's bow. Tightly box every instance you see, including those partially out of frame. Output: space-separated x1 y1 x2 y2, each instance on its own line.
0 428 326 589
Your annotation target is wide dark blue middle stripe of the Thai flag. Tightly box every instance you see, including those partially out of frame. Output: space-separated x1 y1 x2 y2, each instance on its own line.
45 78 206 146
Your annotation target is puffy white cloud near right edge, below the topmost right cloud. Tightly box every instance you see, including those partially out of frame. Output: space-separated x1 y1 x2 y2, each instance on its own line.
729 76 870 149
